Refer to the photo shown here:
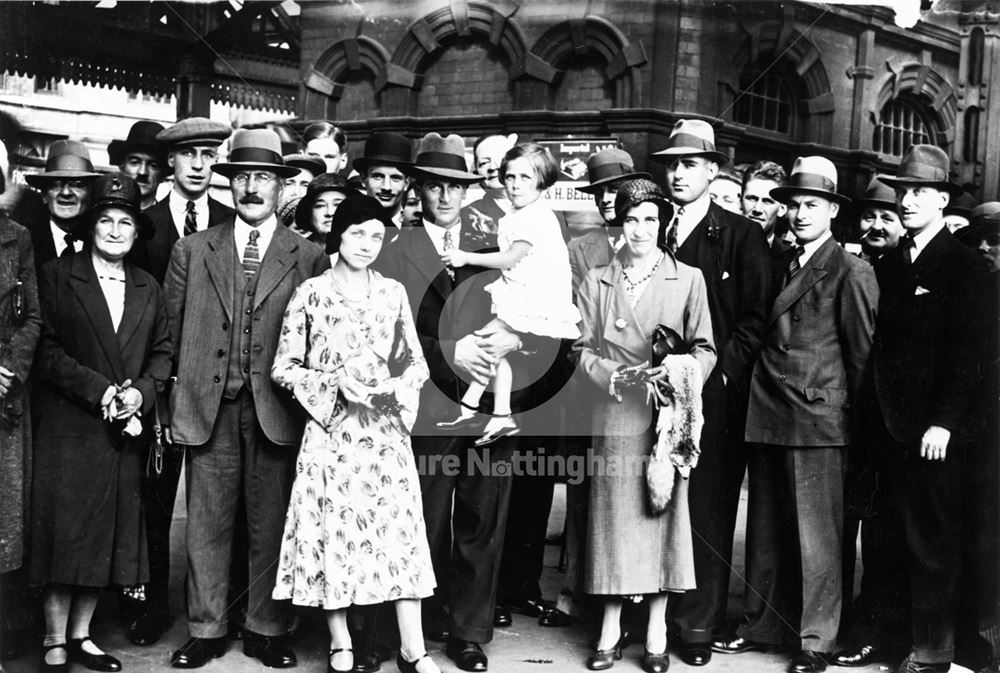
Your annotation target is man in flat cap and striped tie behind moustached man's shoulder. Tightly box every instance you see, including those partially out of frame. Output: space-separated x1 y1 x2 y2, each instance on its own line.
133 117 233 283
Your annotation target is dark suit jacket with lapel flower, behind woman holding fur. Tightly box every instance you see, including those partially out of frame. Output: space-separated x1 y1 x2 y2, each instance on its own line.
661 203 771 387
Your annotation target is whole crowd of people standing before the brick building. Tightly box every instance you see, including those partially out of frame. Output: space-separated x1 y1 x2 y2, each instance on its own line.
0 111 1000 673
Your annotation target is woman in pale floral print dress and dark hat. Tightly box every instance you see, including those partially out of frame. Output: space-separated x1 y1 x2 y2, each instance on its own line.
271 195 438 673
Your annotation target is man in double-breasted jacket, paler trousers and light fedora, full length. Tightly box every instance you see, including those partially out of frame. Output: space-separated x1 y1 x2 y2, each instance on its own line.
737 156 878 673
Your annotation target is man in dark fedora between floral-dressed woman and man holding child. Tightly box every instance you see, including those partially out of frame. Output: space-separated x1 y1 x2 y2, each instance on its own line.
353 132 413 236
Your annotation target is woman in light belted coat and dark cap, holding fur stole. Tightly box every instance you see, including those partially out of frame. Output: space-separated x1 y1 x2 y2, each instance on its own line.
574 180 716 673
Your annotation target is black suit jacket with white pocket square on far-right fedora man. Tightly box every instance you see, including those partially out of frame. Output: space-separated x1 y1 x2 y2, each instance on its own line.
874 228 995 442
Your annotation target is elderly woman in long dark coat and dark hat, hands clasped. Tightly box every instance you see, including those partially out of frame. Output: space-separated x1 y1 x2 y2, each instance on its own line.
30 173 172 671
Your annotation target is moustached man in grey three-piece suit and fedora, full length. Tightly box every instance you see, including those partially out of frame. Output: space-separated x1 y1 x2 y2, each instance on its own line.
164 129 330 668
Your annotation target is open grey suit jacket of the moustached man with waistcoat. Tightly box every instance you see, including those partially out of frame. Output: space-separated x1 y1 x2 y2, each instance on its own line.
163 216 330 446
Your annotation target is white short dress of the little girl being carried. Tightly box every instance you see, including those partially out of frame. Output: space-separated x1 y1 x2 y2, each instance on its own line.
486 199 580 339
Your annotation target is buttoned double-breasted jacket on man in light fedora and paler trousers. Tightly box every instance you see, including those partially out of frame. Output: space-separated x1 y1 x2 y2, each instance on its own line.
746 236 878 447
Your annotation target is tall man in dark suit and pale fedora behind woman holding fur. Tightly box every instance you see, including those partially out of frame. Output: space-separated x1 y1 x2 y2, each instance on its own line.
652 119 770 666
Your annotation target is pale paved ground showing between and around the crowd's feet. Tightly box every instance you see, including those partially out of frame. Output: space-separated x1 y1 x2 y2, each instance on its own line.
4 480 967 673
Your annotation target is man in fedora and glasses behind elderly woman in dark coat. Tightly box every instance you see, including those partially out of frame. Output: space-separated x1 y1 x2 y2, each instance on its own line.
20 140 98 269
